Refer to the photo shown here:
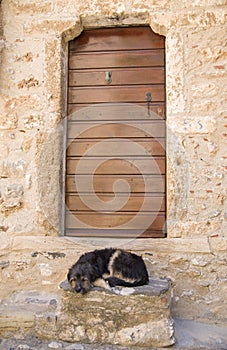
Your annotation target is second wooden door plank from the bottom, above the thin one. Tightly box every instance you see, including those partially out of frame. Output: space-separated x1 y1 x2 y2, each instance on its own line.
66 211 165 231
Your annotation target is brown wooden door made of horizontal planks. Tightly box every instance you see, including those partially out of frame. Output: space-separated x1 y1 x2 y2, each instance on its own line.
66 27 165 237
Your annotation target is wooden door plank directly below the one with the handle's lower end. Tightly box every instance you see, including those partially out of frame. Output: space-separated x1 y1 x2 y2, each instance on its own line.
68 120 165 139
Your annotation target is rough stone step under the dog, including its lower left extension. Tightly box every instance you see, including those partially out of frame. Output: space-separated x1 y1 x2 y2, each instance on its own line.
0 279 174 348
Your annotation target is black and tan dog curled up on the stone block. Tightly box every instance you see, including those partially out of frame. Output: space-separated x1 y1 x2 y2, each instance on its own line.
67 248 149 294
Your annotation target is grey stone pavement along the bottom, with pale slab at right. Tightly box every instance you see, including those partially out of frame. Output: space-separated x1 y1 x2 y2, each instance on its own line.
0 319 227 350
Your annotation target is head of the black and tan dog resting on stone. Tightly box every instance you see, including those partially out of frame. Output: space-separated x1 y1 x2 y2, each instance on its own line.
67 263 94 294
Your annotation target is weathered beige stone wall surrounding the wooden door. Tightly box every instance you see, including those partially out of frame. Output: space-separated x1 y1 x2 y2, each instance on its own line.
0 0 227 322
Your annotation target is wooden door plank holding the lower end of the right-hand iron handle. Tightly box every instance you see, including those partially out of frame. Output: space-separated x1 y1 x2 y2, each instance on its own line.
68 102 165 120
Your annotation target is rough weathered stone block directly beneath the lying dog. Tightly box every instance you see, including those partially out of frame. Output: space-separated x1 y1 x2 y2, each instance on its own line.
36 280 174 347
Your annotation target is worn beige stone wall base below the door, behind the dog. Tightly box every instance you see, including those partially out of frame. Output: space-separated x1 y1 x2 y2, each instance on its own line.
0 237 227 324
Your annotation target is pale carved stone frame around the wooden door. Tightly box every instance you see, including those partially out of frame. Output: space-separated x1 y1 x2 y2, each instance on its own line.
41 14 188 238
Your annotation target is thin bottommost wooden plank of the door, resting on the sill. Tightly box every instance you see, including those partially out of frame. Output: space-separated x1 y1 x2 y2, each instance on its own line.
65 228 166 238
